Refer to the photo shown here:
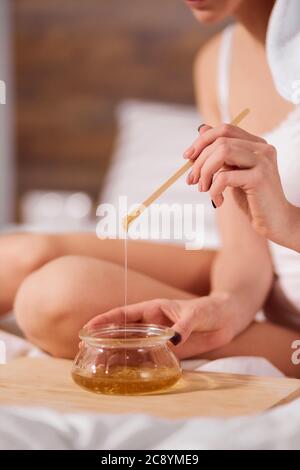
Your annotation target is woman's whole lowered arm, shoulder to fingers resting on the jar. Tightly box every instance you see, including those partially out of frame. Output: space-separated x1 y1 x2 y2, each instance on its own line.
89 39 273 357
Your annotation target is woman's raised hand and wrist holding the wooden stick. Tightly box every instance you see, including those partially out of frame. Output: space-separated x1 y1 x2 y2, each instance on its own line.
184 124 300 249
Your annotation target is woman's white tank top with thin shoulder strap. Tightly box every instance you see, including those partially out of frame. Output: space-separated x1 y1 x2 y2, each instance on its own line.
218 25 300 313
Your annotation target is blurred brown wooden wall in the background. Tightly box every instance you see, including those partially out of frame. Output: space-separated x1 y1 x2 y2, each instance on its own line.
12 0 218 211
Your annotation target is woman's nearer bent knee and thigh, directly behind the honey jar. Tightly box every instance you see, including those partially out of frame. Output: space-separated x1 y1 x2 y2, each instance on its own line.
14 256 193 358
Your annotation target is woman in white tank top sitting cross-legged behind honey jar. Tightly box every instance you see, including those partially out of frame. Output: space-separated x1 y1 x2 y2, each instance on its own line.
0 0 300 377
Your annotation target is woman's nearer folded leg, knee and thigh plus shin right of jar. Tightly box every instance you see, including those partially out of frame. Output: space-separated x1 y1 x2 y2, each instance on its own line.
15 252 300 377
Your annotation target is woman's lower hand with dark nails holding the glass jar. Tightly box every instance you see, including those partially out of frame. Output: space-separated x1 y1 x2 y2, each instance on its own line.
86 292 248 355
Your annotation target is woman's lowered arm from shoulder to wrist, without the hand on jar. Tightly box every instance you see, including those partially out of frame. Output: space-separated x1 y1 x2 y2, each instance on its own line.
194 36 273 334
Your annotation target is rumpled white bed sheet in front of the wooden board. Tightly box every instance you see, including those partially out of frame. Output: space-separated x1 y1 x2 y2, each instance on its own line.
0 400 300 450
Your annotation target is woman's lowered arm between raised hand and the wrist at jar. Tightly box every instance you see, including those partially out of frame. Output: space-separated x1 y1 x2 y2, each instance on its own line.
211 190 273 336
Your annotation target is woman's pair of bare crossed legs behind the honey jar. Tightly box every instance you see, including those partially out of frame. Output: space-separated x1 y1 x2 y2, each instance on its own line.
0 234 300 377
